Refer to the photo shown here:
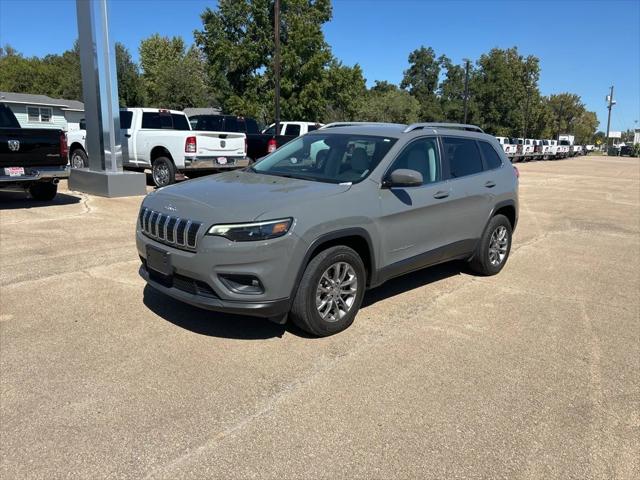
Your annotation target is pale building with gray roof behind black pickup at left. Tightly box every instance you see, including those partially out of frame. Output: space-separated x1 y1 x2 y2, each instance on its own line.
0 92 84 131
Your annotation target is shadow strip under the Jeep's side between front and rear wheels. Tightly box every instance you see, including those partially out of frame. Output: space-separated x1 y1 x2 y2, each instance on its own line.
362 261 467 307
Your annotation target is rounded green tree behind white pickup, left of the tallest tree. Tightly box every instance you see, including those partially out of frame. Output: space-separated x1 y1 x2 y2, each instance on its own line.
140 34 212 110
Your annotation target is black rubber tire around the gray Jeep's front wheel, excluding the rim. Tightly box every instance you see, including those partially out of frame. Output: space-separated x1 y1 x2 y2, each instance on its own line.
290 245 367 337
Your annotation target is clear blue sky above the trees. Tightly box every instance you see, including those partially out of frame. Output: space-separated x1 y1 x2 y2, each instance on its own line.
0 0 640 130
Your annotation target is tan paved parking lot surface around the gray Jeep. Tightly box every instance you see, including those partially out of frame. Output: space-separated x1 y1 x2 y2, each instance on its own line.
0 157 640 479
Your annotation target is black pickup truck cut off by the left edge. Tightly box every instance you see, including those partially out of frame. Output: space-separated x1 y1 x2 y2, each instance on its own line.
0 103 69 201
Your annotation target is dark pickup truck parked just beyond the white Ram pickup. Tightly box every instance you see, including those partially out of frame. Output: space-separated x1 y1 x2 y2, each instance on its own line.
189 114 299 160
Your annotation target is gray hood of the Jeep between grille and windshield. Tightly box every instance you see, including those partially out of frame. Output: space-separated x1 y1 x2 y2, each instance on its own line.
143 170 350 222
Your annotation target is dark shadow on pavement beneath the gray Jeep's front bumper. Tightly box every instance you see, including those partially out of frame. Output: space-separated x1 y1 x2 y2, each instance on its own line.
142 285 288 340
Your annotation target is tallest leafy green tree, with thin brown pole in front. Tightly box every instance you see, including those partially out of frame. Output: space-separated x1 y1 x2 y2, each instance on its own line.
195 0 364 121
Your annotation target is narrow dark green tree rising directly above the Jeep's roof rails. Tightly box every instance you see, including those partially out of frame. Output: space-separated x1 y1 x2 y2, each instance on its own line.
400 47 444 121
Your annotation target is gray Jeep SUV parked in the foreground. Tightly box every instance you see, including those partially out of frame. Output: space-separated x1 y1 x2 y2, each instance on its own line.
136 123 518 336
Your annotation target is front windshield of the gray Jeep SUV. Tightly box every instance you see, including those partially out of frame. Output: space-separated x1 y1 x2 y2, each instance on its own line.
250 132 397 183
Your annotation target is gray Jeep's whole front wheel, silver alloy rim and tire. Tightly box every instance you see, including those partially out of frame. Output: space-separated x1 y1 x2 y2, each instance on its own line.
291 245 367 337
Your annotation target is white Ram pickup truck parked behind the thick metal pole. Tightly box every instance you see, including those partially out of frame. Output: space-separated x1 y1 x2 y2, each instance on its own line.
67 108 250 187
